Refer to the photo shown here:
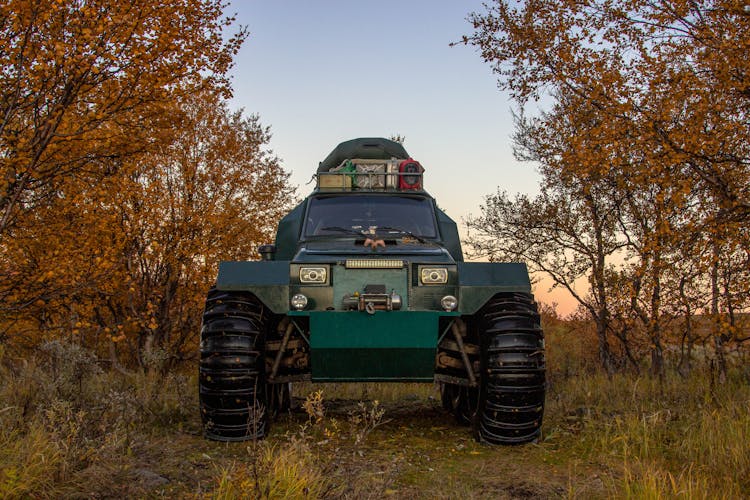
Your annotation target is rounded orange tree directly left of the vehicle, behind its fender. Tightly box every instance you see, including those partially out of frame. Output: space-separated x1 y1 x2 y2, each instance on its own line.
103 95 293 364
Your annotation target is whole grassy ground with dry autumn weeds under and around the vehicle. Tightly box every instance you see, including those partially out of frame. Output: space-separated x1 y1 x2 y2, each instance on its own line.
0 338 750 498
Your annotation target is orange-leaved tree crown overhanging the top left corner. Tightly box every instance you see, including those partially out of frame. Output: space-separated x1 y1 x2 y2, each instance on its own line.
0 0 245 236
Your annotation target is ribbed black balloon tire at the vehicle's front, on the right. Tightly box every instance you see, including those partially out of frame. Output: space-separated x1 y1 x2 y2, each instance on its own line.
473 293 545 444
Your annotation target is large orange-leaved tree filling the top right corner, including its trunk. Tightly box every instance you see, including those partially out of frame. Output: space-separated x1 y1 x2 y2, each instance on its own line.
464 0 750 372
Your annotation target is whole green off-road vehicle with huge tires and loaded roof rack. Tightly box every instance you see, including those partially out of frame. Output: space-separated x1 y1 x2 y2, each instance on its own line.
199 139 545 444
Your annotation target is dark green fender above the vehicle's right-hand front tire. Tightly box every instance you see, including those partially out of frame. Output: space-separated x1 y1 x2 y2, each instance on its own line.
458 262 531 315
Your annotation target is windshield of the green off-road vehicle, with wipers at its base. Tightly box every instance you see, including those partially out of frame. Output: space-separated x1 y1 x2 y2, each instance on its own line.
305 195 437 238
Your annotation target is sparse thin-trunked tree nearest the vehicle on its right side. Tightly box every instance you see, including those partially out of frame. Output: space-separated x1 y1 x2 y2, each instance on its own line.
466 96 633 373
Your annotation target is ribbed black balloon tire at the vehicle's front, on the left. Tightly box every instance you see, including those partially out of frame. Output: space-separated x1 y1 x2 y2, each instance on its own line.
199 290 269 441
